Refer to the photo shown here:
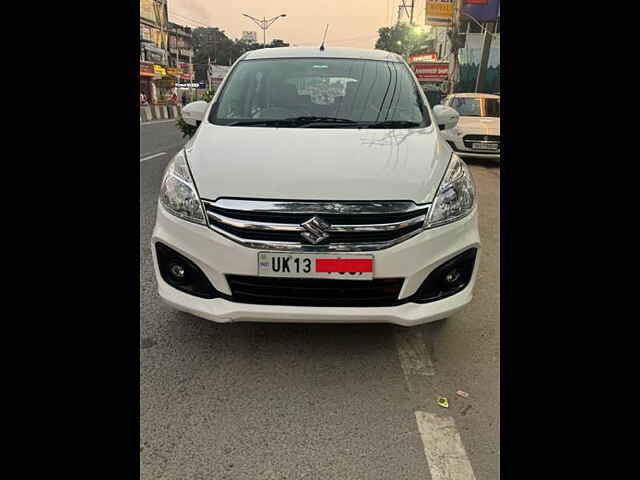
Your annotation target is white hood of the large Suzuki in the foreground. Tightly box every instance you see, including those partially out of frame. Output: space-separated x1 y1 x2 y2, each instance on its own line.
185 122 451 203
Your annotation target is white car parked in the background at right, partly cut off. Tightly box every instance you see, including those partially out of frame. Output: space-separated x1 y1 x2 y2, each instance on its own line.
442 93 500 160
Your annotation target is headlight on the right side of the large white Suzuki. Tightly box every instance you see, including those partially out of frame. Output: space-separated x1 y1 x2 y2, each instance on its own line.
425 153 476 228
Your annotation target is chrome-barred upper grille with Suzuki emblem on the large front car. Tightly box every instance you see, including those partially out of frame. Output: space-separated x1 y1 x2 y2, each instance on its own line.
203 199 428 251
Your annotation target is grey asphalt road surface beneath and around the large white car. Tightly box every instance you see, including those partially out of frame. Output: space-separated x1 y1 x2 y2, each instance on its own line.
140 123 500 480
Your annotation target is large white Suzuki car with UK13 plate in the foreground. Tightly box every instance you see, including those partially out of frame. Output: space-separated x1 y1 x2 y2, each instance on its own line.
151 47 480 326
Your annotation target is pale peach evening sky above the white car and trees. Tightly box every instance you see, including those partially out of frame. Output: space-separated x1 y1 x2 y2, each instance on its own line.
167 0 425 48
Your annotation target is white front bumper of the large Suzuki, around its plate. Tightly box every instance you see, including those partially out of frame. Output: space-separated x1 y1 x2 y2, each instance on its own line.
151 203 480 326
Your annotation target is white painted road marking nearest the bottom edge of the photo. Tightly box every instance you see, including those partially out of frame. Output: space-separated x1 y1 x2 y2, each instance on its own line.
416 412 476 480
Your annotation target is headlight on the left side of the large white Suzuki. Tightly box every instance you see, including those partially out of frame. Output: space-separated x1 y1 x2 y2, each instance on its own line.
160 150 207 225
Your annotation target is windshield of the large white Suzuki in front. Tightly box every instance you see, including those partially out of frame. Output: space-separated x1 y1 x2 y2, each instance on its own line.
209 58 430 128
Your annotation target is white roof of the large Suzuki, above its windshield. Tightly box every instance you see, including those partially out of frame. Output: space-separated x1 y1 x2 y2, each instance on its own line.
242 46 403 62
